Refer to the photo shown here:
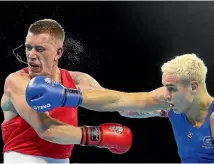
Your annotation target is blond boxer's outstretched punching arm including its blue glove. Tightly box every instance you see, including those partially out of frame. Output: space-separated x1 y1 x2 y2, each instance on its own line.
26 76 169 118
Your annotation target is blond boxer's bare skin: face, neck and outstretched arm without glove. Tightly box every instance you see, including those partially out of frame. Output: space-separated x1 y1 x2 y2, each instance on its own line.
82 70 214 139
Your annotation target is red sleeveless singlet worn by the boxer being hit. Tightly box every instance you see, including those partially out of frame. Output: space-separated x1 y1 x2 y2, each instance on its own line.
1 68 78 159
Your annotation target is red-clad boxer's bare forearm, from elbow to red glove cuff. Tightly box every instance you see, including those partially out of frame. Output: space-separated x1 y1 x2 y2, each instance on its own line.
39 118 82 145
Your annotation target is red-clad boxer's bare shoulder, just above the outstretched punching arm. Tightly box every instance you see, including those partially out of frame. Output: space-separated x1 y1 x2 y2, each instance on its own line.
69 71 102 90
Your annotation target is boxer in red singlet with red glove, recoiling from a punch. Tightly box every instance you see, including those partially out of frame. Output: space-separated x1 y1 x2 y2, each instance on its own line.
1 19 132 163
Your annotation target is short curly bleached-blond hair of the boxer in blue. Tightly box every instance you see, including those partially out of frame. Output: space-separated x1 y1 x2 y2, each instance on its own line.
161 54 207 84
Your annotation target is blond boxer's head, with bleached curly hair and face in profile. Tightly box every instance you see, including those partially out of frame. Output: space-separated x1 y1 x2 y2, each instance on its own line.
161 54 207 113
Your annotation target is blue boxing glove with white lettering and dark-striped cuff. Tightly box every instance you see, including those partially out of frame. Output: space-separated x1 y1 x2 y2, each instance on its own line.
25 76 82 112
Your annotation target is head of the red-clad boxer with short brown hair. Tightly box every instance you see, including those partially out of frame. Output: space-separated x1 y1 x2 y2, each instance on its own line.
25 19 65 76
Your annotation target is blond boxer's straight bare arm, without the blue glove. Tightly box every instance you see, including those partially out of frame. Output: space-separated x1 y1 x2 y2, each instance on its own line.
81 87 169 113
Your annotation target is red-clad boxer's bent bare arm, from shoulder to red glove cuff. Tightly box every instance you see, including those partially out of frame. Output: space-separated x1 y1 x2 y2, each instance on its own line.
1 72 82 144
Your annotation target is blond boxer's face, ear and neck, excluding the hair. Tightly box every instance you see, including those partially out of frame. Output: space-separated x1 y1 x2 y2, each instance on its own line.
162 74 214 128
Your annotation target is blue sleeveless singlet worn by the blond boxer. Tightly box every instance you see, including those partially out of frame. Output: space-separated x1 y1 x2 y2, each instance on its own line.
168 102 214 163
